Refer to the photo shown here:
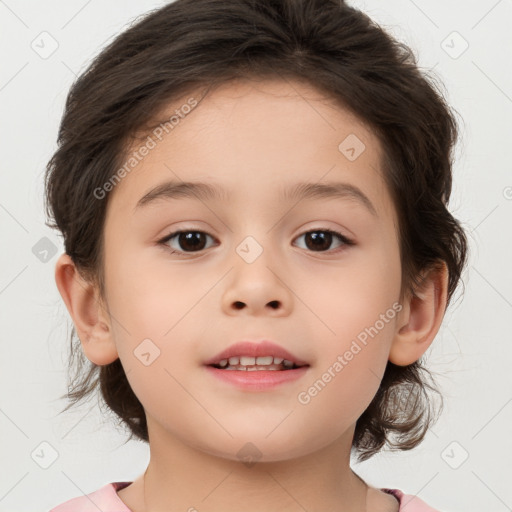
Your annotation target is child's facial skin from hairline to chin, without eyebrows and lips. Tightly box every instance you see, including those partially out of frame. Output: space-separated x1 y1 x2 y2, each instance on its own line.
104 81 401 461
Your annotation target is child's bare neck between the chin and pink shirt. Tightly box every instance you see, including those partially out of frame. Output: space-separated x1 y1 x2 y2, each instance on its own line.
143 418 368 512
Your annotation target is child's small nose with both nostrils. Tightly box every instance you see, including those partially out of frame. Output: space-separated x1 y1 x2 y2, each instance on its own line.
222 251 293 316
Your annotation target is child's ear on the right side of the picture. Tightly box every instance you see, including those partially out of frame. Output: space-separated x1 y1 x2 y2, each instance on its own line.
389 262 448 366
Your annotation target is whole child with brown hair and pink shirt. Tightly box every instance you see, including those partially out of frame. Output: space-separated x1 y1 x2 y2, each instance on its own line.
46 0 466 512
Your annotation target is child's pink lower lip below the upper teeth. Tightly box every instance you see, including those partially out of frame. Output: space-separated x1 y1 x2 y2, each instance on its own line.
206 366 309 391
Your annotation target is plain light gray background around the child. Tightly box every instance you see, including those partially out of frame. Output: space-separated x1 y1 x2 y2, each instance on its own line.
0 0 512 512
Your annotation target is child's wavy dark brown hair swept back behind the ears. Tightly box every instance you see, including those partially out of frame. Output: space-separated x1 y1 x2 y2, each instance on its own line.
46 0 467 460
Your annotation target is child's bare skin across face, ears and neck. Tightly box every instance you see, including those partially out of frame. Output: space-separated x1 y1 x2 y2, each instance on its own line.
56 77 447 512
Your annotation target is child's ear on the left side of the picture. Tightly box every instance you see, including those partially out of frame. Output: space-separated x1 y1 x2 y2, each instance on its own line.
55 253 119 366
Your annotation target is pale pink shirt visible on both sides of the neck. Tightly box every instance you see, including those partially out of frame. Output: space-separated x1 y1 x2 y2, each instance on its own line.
50 482 439 512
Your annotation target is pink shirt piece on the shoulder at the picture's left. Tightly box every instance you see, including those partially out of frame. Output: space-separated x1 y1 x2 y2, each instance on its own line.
49 482 131 512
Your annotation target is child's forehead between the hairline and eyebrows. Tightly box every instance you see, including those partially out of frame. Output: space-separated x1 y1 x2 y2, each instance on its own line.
104 80 389 219
